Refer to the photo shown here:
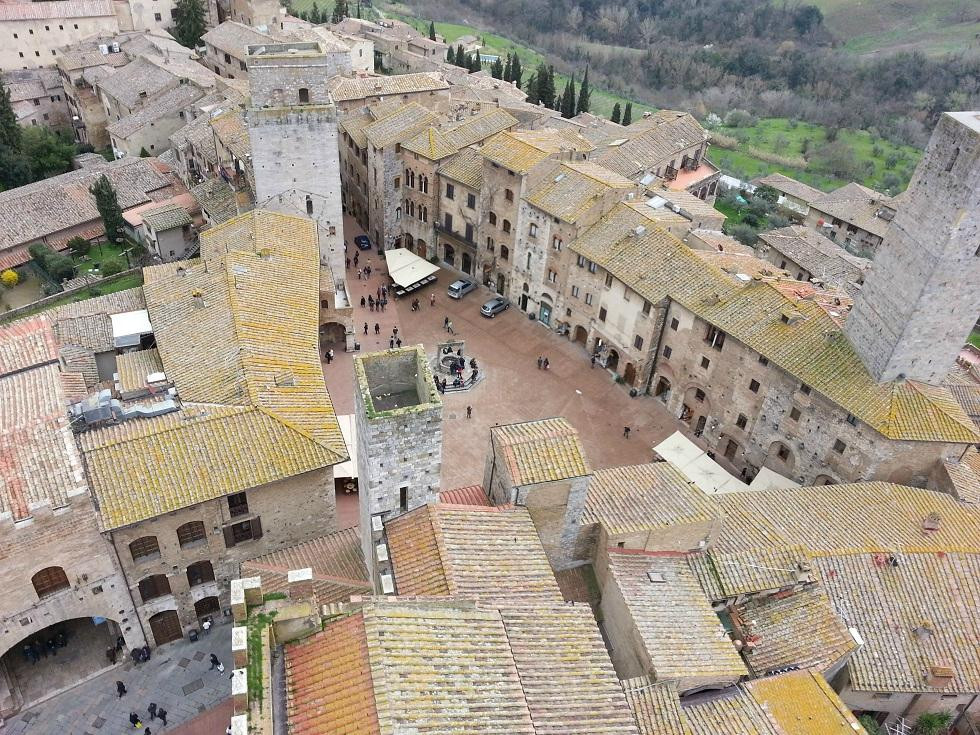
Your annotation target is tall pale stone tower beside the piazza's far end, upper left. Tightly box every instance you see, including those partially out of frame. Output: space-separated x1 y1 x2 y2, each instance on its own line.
246 41 350 278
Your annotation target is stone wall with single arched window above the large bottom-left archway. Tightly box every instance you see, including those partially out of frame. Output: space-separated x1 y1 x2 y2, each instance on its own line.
0 494 145 655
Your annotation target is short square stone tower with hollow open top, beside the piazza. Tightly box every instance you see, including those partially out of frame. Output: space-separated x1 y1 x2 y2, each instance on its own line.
354 345 442 591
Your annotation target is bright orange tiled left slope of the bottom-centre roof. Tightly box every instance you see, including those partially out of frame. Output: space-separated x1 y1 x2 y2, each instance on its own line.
285 614 381 735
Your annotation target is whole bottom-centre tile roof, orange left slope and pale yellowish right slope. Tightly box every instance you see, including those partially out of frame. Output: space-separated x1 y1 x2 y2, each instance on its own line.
286 598 638 735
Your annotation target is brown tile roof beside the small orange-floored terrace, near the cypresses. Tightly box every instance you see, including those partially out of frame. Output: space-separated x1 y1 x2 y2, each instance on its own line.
595 110 708 178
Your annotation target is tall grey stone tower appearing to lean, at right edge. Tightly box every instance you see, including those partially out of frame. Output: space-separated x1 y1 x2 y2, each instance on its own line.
844 112 980 383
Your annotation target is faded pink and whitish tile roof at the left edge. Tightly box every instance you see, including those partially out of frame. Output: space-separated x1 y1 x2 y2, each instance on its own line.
0 316 87 521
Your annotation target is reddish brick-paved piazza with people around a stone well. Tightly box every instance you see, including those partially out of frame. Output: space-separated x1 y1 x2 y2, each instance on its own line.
323 219 687 489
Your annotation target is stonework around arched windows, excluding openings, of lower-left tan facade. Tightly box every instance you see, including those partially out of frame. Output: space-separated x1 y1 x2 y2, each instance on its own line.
111 467 337 645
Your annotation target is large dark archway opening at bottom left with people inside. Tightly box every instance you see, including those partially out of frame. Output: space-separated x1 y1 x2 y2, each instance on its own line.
0 617 127 712
